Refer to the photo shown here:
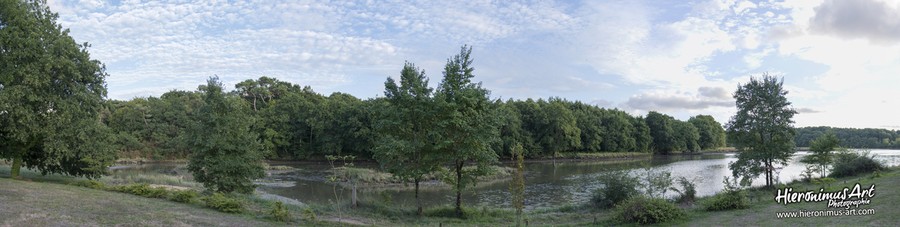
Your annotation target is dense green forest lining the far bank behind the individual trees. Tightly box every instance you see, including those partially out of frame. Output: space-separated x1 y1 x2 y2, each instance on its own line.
101 77 725 160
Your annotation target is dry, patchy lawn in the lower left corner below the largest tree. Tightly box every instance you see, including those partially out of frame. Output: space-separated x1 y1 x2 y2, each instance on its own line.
0 178 280 226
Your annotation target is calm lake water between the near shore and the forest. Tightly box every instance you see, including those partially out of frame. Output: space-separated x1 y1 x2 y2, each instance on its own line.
114 150 900 209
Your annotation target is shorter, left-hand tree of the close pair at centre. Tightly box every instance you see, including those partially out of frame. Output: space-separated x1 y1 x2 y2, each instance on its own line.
374 62 440 215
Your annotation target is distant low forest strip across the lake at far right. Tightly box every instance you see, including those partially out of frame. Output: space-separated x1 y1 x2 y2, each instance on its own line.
794 126 900 149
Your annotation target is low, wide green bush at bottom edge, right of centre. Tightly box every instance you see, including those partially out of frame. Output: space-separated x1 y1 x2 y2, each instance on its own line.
614 196 685 224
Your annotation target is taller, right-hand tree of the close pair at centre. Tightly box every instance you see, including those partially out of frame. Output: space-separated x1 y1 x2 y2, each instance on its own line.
435 46 498 217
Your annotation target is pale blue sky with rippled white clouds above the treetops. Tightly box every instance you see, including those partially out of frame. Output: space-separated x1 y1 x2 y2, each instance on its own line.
48 0 900 129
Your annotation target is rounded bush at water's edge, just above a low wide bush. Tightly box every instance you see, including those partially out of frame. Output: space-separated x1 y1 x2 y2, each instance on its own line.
591 171 640 208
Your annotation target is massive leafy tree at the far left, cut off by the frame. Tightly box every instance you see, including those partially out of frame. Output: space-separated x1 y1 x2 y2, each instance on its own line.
0 0 115 178
